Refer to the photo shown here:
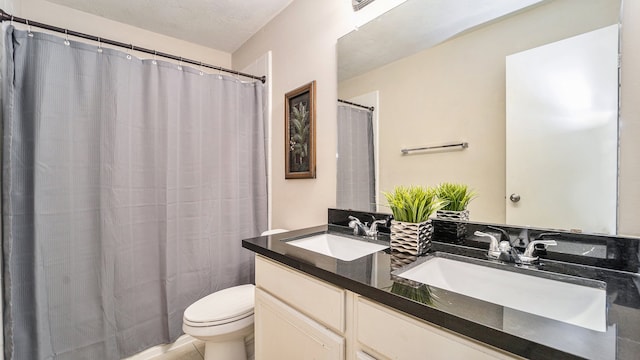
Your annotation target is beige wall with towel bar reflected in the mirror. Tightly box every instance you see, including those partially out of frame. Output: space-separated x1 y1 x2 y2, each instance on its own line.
339 1 619 223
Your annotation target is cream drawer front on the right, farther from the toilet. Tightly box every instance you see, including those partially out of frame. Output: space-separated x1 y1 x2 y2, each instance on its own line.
356 297 517 360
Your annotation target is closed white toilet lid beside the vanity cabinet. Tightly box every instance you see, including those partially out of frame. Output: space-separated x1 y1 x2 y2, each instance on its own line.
184 284 255 323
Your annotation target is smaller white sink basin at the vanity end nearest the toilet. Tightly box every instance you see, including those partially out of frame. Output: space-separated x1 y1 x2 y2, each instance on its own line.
287 234 389 261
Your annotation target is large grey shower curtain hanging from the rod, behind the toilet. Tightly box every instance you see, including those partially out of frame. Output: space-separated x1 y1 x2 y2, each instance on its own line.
2 26 267 360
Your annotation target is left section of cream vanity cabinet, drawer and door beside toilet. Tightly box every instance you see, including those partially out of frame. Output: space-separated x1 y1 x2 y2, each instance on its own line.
255 256 346 360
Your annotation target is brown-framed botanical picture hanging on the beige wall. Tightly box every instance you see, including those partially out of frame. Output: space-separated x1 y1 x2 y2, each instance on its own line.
284 80 316 179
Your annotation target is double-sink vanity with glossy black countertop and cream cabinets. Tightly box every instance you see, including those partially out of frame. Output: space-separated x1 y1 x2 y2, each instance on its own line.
243 212 640 359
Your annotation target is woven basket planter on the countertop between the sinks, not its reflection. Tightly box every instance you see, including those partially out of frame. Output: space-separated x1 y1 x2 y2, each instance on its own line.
391 220 433 255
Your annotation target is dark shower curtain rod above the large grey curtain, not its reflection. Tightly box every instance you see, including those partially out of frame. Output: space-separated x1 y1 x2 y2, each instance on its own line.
0 9 267 83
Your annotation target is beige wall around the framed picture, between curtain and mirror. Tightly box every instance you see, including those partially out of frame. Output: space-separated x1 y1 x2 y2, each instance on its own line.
233 0 353 229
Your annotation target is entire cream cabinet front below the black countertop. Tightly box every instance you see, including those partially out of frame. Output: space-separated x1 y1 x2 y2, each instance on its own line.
255 255 519 360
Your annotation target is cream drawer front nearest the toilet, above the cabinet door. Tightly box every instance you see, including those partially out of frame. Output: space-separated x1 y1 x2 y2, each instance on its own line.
256 255 346 334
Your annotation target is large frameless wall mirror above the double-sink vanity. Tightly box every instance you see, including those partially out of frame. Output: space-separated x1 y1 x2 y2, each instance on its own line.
337 0 640 236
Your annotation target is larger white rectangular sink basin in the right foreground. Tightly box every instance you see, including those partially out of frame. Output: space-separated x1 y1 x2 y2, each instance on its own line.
398 256 607 332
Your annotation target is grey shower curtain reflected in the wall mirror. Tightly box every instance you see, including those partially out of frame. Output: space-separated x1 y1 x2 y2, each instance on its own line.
336 105 376 211
